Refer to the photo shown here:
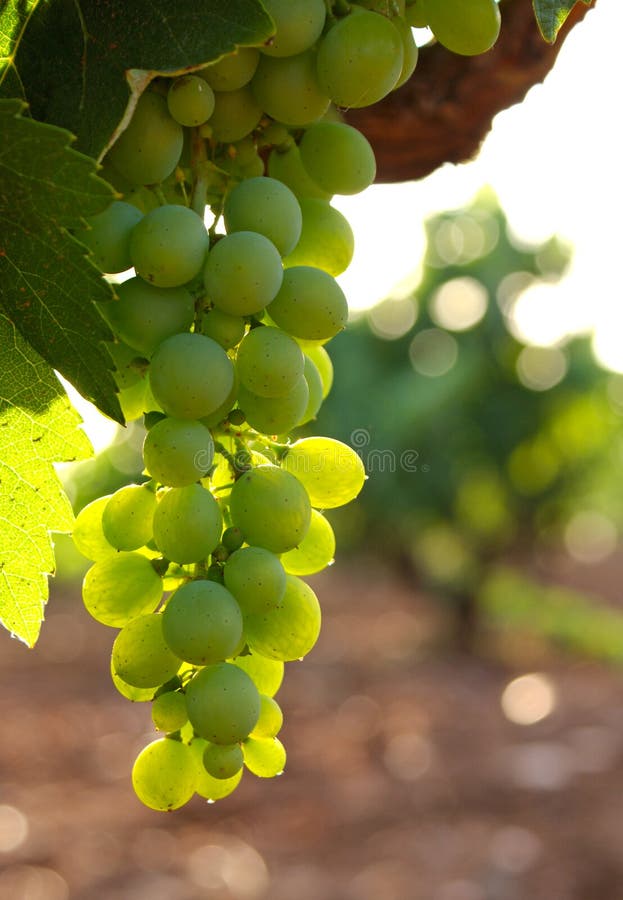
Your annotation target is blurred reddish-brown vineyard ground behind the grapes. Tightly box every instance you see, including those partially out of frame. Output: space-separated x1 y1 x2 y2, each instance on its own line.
0 562 623 900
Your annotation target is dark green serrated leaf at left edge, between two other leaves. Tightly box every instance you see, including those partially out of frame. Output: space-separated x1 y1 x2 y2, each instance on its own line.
0 100 123 422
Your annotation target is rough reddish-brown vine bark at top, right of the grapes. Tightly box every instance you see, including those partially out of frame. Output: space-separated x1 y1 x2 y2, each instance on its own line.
345 0 589 182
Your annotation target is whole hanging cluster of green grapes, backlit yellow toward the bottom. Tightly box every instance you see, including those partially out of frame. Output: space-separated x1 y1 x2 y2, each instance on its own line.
74 0 497 810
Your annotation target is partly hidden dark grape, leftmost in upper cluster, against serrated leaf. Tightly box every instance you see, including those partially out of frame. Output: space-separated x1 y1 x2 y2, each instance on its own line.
76 200 143 274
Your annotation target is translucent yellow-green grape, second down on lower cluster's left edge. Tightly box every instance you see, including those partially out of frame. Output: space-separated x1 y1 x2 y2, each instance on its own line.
82 552 163 624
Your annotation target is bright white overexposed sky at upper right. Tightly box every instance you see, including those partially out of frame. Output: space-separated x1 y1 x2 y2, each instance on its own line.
334 0 623 370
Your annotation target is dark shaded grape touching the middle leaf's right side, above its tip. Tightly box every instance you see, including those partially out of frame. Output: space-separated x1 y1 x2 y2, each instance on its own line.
99 277 195 357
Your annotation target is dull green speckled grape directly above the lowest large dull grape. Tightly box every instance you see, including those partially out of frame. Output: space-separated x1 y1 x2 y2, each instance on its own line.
162 581 242 666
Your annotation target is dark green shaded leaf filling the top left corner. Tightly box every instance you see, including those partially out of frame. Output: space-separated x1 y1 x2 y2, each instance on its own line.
0 0 274 158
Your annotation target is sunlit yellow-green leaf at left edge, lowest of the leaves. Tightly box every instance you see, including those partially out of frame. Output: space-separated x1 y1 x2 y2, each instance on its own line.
0 313 91 647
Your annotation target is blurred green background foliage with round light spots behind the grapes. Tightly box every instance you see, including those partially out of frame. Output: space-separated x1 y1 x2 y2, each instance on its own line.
57 190 623 662
